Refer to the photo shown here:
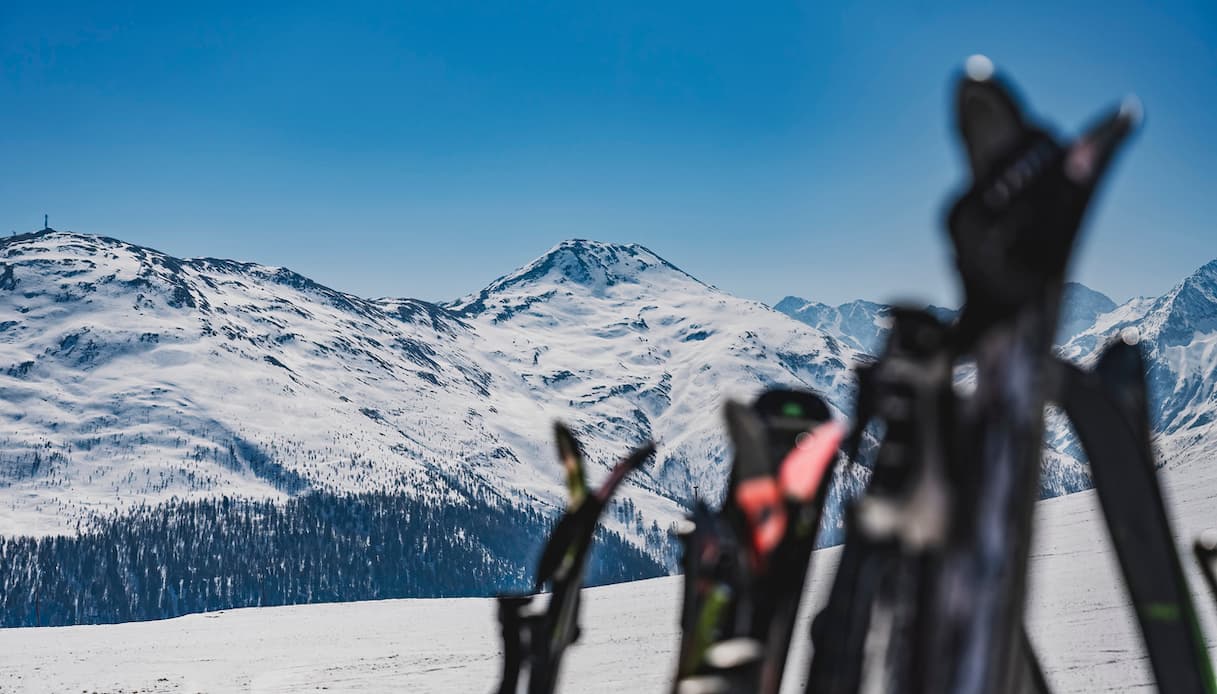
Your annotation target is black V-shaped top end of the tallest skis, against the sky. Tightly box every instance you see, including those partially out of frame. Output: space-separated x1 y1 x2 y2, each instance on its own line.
948 58 1140 348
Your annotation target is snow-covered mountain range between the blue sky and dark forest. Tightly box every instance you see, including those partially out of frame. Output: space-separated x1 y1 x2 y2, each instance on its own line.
0 231 1217 584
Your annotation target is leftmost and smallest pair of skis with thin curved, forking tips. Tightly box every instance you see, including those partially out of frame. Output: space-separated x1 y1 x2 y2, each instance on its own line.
498 422 655 694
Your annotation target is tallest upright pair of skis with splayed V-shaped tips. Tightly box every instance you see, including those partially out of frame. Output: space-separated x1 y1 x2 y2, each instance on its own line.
899 58 1140 694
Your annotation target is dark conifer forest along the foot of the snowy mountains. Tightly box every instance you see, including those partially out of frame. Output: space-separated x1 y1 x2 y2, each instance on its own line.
0 492 666 627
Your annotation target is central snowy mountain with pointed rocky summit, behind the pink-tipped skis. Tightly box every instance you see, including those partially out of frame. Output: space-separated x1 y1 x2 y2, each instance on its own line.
447 240 858 508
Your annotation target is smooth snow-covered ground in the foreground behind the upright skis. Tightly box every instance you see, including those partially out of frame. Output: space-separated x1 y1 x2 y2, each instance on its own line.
0 448 1217 694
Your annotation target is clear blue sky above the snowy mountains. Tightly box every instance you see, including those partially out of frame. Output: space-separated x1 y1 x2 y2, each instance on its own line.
0 0 1217 303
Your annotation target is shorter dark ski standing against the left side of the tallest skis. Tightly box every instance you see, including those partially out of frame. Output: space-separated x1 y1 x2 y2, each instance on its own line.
806 308 953 694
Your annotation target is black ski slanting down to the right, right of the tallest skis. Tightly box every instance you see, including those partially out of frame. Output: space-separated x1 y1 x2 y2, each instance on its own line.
1061 342 1217 694
